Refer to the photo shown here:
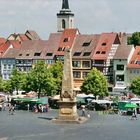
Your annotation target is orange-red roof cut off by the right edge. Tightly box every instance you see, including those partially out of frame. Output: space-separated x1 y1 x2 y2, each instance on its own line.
127 46 140 68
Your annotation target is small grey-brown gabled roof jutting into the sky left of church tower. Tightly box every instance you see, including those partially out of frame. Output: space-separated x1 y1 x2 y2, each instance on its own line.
25 30 40 40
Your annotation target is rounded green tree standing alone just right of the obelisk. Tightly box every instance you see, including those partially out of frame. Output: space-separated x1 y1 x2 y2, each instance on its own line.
81 68 108 98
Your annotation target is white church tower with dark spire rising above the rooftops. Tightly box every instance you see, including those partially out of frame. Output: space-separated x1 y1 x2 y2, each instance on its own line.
57 0 74 32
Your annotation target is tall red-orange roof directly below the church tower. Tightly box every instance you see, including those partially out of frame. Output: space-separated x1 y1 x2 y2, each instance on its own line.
56 29 80 55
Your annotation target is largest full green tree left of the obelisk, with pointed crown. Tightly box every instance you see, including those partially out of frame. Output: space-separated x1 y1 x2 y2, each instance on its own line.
24 61 56 98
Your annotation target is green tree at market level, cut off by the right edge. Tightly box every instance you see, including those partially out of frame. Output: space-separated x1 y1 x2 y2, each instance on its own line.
130 77 140 95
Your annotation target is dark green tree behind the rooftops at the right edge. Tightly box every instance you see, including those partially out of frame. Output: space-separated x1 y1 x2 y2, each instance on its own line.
127 32 140 46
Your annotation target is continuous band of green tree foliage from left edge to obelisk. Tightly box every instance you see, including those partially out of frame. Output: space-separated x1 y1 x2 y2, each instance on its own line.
0 61 63 97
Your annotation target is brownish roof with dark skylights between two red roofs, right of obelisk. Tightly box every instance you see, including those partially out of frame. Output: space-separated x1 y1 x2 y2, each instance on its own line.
72 35 100 59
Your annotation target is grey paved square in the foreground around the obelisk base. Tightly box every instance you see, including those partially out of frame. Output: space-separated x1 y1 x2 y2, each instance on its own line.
0 110 140 140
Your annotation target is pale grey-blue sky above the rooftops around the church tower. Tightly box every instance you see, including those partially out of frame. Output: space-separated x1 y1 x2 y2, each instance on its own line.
0 0 140 39
